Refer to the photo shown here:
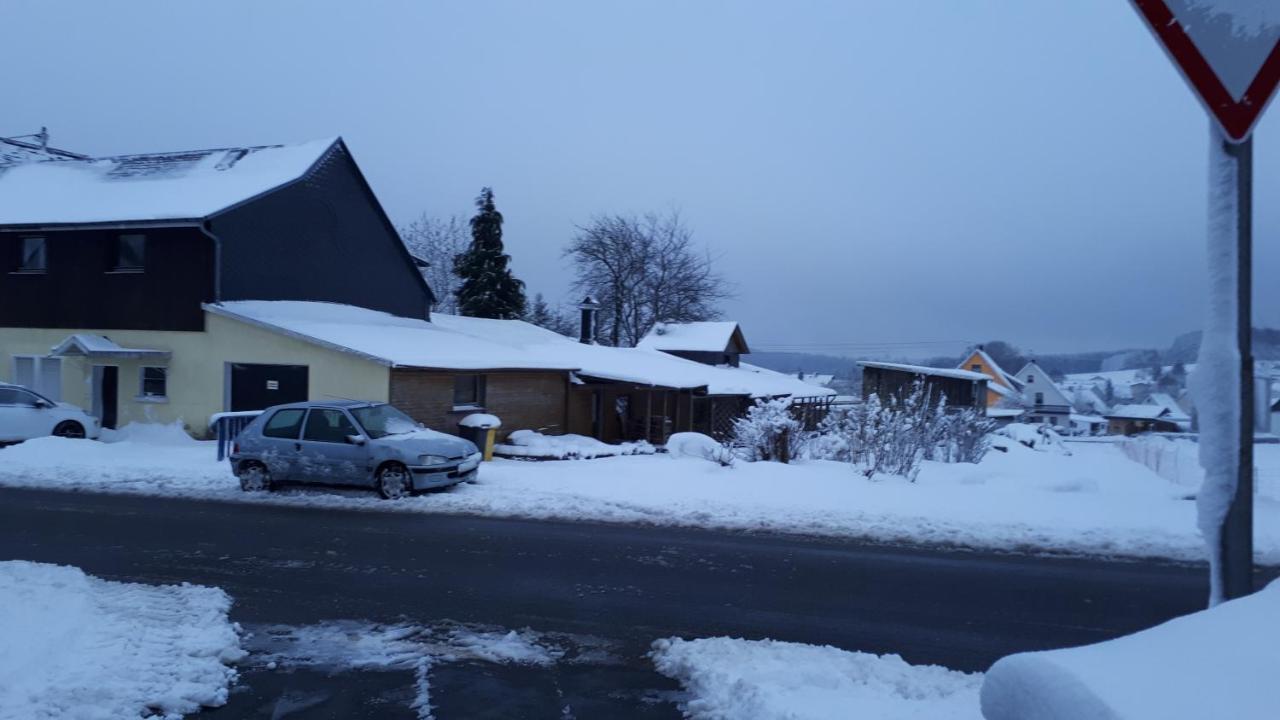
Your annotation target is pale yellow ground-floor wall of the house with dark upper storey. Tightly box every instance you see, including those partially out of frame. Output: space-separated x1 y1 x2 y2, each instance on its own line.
0 313 390 437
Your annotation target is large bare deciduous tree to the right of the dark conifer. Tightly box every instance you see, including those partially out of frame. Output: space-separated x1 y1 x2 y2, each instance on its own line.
564 213 730 346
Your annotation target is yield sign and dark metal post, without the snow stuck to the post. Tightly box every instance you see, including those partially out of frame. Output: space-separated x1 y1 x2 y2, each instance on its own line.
1132 0 1280 602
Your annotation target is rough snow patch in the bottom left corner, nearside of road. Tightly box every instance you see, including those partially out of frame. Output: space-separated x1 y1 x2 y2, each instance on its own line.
0 560 244 720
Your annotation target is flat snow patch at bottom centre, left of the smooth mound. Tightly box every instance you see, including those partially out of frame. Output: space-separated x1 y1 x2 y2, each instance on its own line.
650 638 982 720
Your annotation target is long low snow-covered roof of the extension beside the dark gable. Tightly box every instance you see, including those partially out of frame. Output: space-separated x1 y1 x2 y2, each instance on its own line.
205 300 835 397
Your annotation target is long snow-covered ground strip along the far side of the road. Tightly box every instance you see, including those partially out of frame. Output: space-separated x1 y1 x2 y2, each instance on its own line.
0 427 1280 565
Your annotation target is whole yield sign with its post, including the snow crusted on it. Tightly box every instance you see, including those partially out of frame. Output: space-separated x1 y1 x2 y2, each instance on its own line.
1132 0 1280 605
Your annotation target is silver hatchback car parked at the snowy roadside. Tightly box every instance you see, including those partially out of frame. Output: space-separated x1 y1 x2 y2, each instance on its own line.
230 400 480 500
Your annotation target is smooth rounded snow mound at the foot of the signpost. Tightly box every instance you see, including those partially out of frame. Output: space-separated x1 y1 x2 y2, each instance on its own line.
982 583 1280 720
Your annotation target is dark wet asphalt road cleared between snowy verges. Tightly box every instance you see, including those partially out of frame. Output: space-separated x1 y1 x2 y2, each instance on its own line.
0 489 1261 720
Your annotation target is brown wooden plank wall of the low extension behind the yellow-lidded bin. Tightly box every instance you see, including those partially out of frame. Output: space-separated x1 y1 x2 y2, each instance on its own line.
389 368 568 441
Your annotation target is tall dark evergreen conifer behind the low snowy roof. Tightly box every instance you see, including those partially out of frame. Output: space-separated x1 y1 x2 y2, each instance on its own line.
453 187 525 320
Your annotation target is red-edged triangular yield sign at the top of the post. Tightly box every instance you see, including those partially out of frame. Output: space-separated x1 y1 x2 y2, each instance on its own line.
1132 0 1280 142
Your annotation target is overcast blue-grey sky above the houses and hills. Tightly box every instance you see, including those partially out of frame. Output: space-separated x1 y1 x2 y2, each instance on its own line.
0 0 1280 354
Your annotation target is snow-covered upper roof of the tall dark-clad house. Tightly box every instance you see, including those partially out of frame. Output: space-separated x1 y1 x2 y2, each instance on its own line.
0 138 338 225
